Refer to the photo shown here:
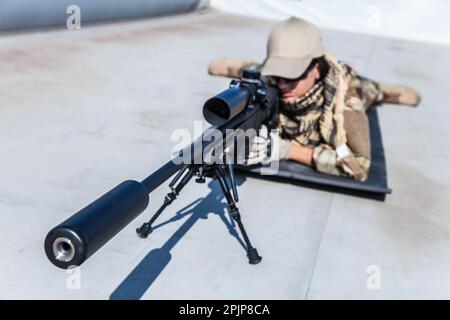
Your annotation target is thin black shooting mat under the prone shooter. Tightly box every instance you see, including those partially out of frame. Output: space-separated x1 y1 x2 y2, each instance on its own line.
235 108 392 201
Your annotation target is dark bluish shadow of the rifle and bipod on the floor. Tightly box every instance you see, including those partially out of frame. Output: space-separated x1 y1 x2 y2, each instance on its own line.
109 176 247 300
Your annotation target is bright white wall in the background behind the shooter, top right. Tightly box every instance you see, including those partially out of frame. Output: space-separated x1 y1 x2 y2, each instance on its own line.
210 0 450 45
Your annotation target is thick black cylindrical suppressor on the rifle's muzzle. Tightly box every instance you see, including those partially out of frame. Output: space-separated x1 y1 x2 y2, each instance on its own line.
45 180 149 269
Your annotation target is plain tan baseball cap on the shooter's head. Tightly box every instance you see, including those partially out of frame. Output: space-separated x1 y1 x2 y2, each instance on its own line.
261 17 325 79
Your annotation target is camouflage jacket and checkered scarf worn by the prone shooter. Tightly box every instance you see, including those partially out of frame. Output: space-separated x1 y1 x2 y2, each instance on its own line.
272 54 383 181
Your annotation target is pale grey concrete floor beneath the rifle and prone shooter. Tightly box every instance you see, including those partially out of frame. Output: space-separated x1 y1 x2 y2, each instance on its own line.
0 11 450 299
